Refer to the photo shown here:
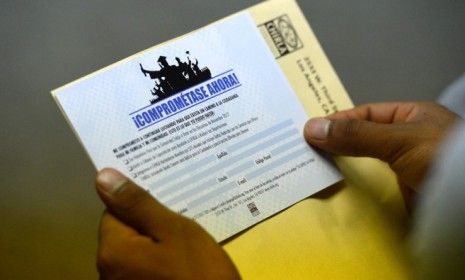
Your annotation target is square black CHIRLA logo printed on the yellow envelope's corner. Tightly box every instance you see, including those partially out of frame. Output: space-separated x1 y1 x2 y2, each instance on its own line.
258 15 303 58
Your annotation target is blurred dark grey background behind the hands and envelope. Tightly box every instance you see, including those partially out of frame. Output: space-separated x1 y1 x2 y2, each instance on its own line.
0 0 465 279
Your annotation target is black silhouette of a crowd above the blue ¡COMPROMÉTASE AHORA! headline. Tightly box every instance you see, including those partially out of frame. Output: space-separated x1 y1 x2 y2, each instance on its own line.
139 51 211 104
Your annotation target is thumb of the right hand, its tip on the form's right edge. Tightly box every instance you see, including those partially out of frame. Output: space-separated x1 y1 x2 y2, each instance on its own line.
304 118 411 163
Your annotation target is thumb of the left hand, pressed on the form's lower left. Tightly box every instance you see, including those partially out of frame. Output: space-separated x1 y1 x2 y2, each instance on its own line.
95 168 180 241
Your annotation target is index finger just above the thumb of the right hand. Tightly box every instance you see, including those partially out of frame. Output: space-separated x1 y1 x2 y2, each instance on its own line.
327 102 418 123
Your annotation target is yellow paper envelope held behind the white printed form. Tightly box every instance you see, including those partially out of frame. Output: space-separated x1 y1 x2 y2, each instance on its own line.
224 0 411 279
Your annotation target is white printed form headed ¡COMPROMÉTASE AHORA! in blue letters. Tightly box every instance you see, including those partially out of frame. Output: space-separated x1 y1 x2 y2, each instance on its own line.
52 11 341 241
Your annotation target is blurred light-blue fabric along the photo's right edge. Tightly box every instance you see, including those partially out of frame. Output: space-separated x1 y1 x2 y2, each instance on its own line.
411 122 465 279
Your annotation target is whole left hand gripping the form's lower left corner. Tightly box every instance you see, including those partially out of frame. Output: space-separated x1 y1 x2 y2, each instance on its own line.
96 169 240 279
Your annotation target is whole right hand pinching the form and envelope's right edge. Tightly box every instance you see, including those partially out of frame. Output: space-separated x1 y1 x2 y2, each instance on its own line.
304 102 459 191
